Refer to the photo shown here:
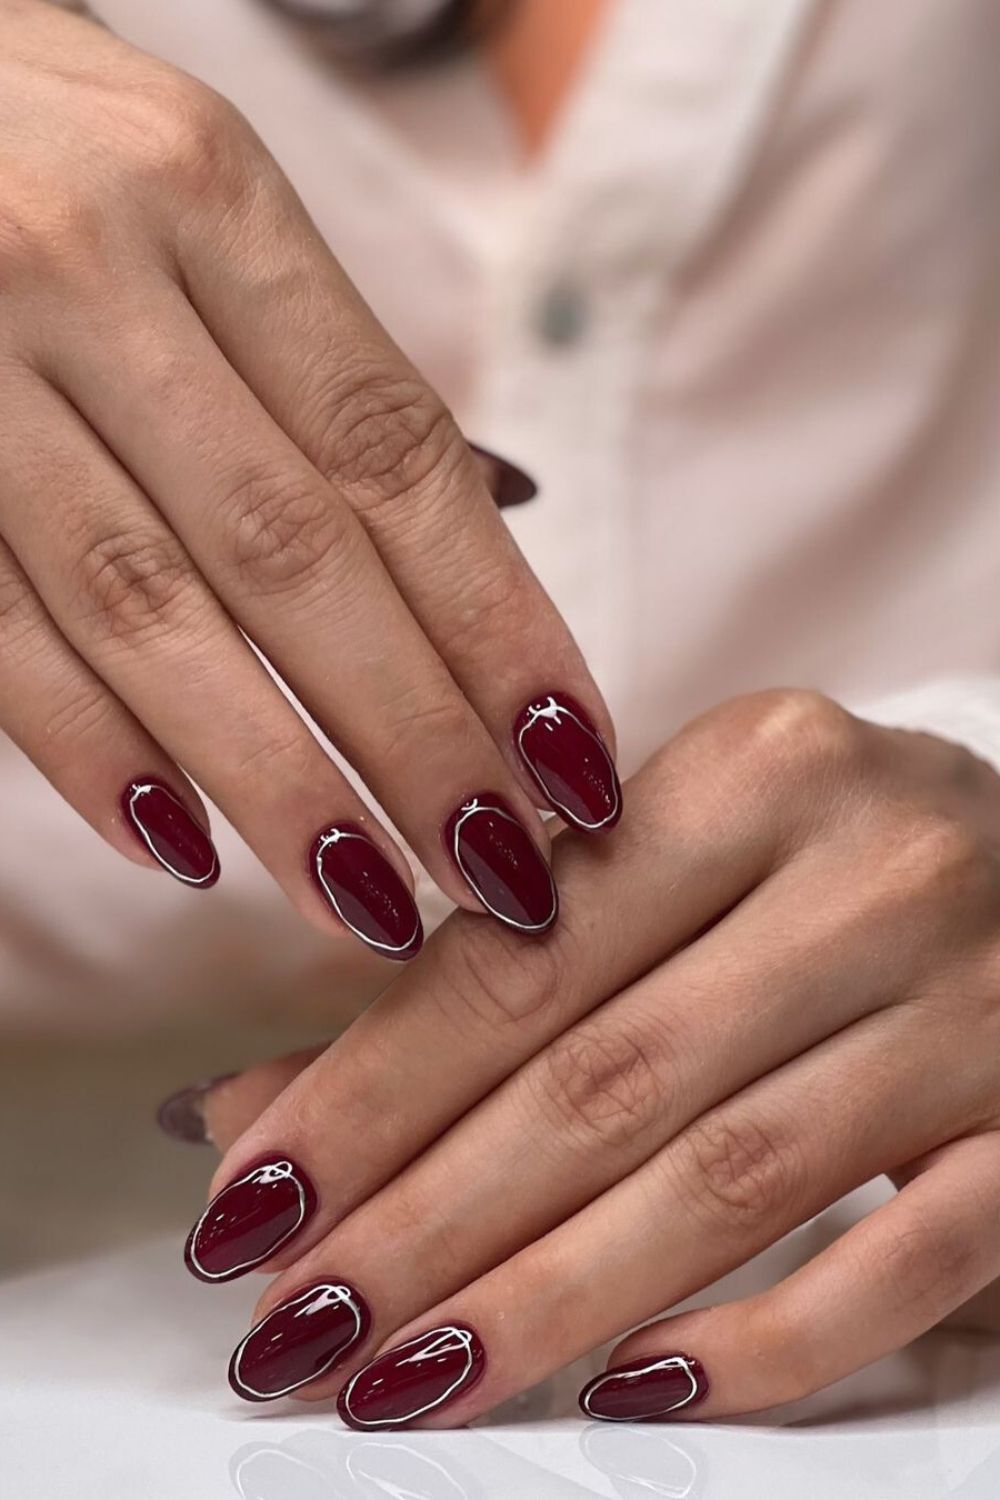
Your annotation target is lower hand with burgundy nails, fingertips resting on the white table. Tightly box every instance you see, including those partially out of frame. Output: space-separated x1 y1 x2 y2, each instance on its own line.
187 692 1000 1428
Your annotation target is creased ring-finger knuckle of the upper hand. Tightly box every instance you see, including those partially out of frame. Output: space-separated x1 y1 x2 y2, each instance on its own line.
75 531 193 645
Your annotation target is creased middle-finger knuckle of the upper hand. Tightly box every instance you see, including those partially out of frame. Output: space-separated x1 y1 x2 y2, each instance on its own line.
220 468 348 594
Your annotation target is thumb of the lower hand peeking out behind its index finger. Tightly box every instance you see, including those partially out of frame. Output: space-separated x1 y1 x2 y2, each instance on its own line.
156 1047 324 1151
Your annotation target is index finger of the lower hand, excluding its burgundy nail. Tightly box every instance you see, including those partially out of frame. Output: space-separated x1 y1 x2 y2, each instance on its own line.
191 723 787 1269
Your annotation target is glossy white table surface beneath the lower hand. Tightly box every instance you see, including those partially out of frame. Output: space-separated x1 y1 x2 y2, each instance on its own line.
0 1236 1000 1500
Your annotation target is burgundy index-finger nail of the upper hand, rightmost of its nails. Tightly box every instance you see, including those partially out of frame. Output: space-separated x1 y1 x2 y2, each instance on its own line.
514 693 622 833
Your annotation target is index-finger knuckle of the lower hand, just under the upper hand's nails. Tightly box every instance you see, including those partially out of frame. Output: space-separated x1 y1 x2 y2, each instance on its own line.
438 914 573 1046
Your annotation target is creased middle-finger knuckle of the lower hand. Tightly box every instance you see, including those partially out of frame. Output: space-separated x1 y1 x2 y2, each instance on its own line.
535 1020 661 1151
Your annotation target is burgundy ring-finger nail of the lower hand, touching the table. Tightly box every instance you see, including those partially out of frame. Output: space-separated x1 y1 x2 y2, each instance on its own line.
337 1323 486 1431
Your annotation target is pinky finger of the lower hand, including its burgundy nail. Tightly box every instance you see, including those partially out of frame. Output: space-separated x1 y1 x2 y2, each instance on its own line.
580 1133 1000 1422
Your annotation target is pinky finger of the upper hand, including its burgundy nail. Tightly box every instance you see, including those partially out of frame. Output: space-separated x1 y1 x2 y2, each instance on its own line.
0 542 219 890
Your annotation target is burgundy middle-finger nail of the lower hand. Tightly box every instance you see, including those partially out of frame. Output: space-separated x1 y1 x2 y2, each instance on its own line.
229 1281 372 1401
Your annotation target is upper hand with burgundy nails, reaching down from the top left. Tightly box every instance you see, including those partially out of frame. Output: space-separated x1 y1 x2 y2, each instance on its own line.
0 0 618 959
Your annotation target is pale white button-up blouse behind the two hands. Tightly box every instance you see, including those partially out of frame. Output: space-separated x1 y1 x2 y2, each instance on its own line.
7 0 1000 1031
